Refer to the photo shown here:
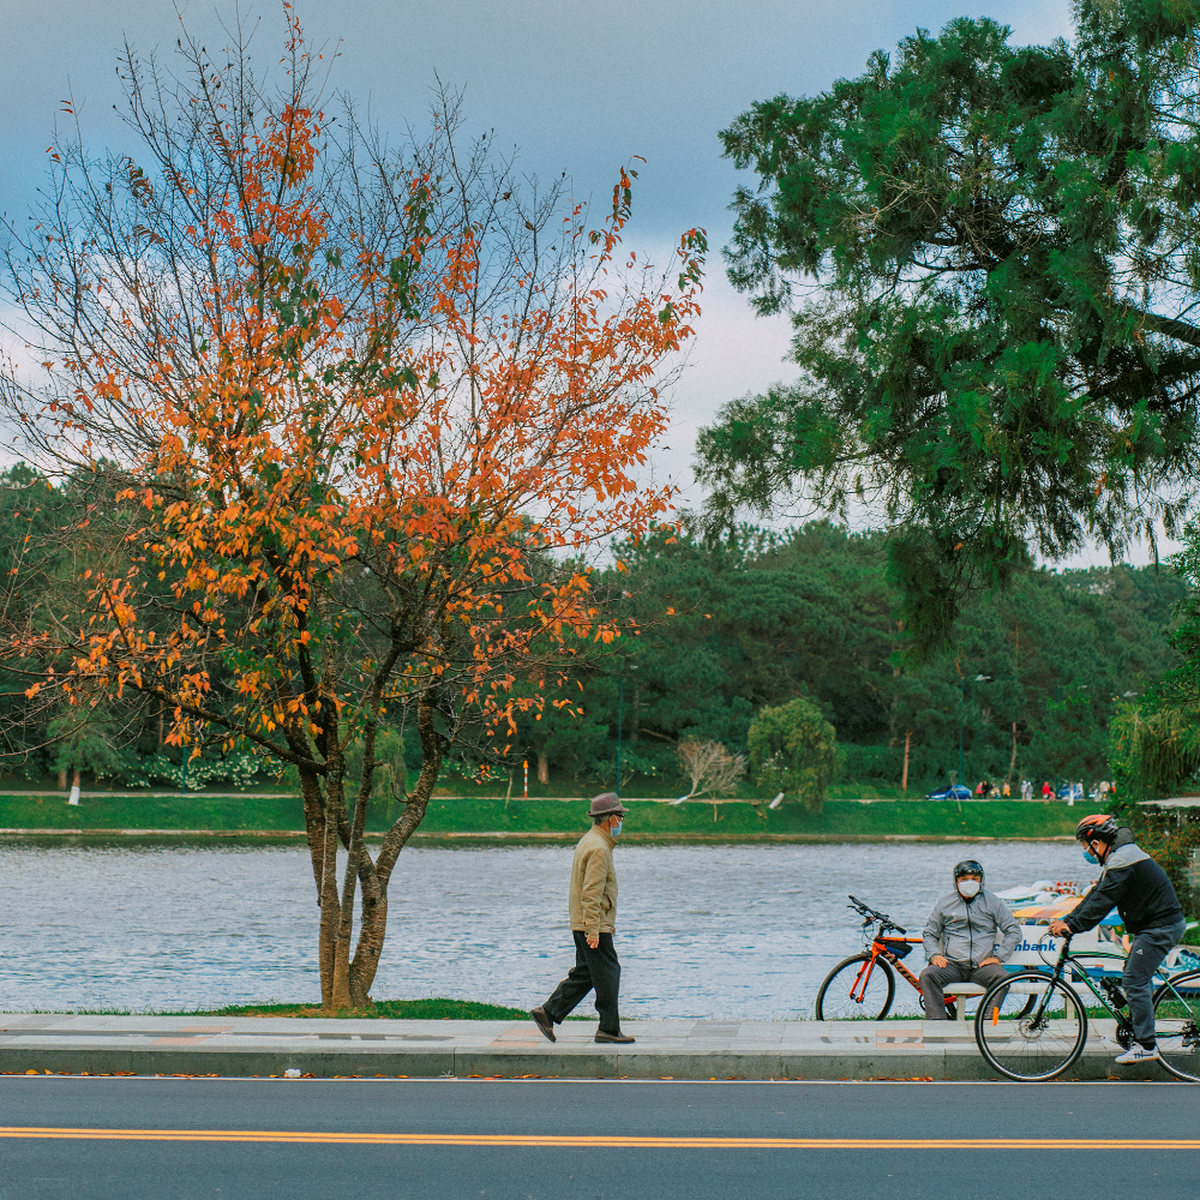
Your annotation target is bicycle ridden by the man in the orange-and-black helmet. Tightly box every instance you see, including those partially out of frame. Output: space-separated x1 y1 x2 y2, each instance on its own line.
974 937 1200 1082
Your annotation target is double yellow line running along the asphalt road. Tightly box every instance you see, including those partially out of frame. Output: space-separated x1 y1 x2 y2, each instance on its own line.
0 1126 1200 1150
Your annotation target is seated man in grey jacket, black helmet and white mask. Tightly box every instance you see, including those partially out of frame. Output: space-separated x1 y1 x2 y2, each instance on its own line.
920 858 1021 1021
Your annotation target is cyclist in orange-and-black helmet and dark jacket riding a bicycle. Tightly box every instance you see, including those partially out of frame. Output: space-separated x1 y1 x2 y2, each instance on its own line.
1050 812 1186 1063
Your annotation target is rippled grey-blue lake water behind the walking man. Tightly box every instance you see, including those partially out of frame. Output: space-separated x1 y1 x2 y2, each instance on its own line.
0 842 1091 1020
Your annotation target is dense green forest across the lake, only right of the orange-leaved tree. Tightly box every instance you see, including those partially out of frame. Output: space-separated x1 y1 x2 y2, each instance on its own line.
504 522 1187 792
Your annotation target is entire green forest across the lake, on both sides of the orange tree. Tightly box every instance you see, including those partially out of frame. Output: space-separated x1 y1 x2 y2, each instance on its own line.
0 467 1187 794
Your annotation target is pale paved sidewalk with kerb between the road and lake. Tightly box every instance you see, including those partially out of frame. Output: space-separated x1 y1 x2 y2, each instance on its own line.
0 1013 1152 1080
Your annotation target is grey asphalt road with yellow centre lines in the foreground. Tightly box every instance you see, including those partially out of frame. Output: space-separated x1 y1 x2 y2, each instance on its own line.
0 1075 1200 1200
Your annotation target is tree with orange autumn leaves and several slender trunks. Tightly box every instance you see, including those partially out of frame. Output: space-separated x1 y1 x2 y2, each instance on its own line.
2 12 704 1010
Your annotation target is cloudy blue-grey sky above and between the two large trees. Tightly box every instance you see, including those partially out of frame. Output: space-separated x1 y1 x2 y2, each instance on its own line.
0 0 1147 560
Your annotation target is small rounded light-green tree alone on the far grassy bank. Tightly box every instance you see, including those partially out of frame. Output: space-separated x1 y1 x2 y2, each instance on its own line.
749 696 839 812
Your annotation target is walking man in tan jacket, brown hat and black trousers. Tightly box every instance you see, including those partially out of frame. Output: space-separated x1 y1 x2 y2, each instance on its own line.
529 792 634 1045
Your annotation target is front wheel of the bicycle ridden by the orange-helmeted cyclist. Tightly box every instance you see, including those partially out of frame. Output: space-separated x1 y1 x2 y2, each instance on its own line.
976 971 1087 1082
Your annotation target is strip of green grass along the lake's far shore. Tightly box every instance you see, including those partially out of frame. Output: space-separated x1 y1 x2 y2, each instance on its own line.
0 793 1086 845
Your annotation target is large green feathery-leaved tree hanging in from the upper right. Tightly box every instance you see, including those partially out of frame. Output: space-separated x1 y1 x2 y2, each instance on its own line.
700 0 1200 649
